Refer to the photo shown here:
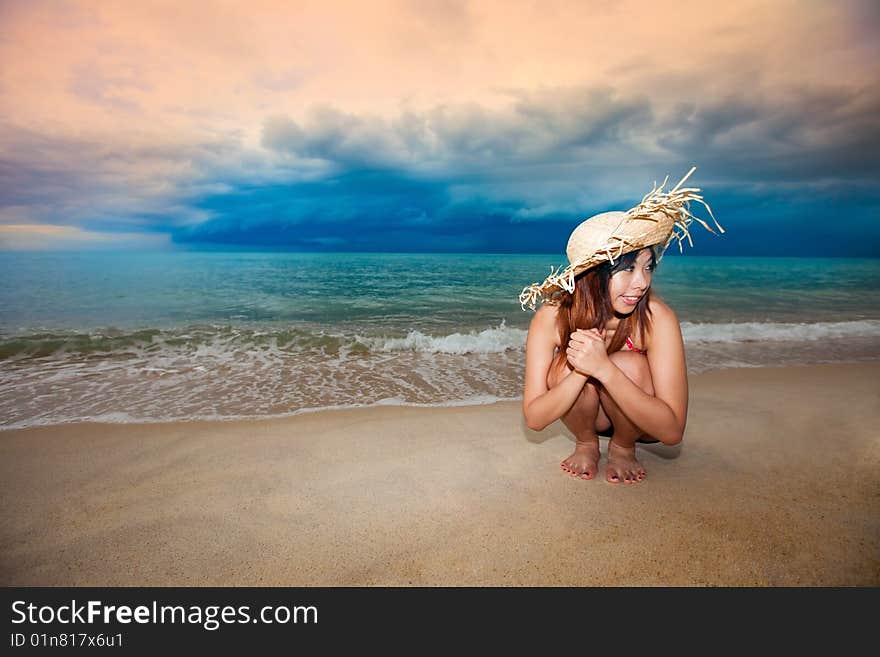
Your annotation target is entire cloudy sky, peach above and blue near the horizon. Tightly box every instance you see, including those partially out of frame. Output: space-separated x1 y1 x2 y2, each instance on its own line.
0 0 880 257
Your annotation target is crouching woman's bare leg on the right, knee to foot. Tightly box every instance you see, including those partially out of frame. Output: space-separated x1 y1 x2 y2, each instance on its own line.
598 351 654 484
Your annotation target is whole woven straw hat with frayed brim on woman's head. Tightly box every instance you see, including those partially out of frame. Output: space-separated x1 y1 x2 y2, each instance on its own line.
519 167 724 310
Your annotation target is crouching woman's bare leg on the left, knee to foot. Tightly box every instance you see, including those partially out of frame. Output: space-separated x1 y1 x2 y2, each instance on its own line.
547 366 610 479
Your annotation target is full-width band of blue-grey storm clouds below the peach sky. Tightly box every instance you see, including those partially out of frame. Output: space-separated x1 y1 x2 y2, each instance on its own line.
0 83 880 255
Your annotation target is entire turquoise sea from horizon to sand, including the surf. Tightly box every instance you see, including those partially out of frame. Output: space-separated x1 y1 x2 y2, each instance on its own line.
0 252 880 429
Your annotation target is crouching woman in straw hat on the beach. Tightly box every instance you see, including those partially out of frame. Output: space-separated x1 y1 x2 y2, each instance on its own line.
520 168 724 483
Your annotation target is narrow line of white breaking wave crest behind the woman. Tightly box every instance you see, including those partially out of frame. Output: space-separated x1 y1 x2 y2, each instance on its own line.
0 320 880 358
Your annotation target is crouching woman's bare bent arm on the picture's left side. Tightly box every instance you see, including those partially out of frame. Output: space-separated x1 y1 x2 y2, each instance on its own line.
523 305 587 431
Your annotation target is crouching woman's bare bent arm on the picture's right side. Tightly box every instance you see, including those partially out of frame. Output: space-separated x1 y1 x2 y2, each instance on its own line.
592 302 688 445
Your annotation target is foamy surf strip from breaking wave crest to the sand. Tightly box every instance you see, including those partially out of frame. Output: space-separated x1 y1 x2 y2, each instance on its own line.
0 320 880 429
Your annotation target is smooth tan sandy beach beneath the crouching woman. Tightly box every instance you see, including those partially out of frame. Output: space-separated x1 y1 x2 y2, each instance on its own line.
0 363 880 586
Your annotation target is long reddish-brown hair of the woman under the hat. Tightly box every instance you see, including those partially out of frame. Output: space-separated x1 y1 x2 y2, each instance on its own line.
550 247 657 376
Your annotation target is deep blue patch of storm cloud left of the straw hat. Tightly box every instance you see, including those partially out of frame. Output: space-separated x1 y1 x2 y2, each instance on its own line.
174 170 572 252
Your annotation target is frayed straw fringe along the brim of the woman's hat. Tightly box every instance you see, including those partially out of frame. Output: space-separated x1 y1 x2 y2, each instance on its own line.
519 167 724 310
